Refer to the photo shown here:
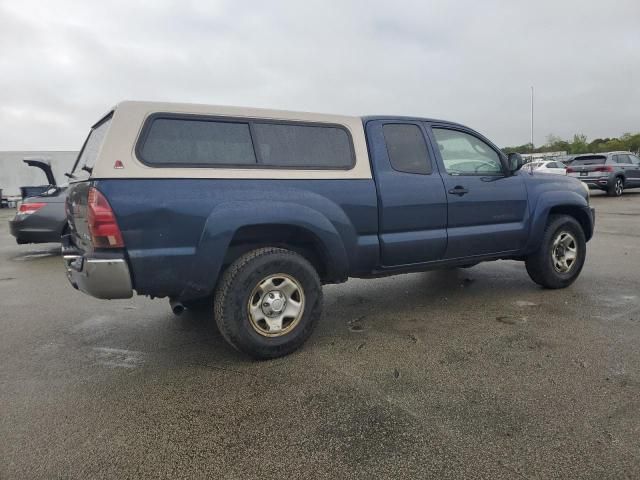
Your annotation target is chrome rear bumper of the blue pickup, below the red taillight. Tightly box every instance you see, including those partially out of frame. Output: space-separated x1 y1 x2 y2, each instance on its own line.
62 255 133 299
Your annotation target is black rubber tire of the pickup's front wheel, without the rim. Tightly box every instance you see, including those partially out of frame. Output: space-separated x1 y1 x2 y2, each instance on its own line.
525 215 587 289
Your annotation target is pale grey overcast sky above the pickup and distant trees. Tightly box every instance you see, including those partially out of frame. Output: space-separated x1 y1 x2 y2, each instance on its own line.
0 0 640 150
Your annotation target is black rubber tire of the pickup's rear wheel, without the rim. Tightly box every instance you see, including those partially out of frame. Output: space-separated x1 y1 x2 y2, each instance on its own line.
214 247 322 359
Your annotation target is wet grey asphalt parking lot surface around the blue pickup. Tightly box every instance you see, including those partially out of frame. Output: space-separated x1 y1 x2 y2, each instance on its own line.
0 193 640 479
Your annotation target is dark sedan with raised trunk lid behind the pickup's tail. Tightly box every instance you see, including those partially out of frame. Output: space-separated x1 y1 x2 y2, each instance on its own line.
9 160 67 244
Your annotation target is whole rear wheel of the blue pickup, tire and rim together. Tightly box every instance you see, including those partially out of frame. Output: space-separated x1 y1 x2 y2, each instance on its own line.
214 247 322 359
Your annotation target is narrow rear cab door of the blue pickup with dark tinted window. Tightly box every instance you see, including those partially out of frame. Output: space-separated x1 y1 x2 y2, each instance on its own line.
366 120 447 267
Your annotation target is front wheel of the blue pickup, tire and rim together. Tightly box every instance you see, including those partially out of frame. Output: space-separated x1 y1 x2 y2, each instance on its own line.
525 215 587 288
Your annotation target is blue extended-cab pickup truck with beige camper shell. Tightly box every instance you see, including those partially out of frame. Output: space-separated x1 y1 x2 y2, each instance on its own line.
63 102 594 358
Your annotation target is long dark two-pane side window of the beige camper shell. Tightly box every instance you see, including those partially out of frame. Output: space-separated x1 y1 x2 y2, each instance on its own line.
136 113 355 170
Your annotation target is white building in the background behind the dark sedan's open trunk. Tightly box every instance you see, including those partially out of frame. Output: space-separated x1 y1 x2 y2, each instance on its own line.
0 151 78 197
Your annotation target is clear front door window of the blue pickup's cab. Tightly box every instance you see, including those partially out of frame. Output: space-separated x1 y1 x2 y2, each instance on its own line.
433 128 503 175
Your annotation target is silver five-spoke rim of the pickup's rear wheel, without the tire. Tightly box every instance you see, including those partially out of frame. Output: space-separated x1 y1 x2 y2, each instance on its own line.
247 273 304 337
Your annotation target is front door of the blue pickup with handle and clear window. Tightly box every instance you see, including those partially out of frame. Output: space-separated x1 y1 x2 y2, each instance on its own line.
427 123 529 259
